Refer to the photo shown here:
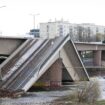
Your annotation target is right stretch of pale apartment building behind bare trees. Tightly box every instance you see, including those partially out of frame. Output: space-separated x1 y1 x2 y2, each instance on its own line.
69 23 105 41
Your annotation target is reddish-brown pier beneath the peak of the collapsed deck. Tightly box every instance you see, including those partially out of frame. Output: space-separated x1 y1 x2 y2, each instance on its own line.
34 59 62 87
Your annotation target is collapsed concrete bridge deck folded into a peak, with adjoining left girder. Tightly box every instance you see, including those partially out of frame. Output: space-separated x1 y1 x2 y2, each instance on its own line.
0 35 89 91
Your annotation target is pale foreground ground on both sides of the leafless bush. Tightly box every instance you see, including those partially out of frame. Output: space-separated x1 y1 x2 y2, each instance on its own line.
0 77 105 105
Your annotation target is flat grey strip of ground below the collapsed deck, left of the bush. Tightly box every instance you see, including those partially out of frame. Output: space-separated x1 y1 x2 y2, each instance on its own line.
0 90 71 105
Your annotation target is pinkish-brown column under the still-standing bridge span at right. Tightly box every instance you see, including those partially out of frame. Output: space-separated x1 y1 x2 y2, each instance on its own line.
93 50 102 66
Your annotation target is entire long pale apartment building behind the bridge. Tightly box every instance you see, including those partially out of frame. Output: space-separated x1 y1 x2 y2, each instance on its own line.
40 21 105 41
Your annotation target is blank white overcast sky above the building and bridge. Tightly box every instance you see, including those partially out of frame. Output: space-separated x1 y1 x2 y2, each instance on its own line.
0 0 105 36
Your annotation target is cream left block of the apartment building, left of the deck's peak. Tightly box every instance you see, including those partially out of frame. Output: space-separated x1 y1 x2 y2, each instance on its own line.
40 21 69 38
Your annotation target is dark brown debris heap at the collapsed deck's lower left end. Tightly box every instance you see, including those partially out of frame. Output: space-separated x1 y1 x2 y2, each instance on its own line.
0 89 25 98
